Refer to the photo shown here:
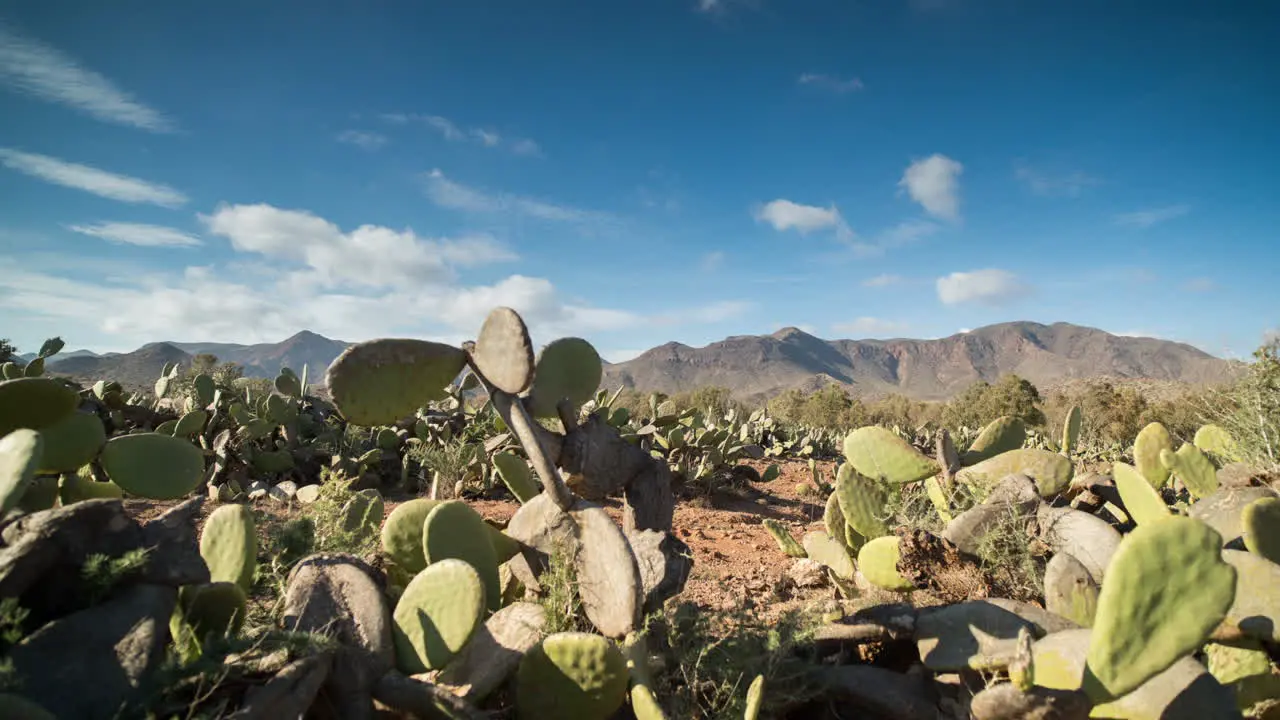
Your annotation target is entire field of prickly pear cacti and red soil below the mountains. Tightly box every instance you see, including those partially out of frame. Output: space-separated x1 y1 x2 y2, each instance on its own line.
0 307 1280 720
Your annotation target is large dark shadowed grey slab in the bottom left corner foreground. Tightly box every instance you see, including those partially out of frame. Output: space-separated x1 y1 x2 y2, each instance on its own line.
9 584 178 720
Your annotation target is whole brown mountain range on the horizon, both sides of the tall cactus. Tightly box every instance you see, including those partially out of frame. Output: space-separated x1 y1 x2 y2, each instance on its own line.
22 322 1234 400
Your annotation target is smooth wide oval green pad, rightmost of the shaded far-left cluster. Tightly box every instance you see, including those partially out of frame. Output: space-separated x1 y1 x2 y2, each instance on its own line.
100 433 205 500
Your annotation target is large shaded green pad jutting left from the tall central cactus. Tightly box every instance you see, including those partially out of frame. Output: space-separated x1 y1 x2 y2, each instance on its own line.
326 338 467 427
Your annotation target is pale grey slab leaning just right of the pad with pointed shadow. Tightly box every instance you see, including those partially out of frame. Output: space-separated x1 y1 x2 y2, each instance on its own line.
436 602 547 702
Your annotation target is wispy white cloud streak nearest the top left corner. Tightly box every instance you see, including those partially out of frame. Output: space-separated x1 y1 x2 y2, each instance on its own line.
0 23 174 132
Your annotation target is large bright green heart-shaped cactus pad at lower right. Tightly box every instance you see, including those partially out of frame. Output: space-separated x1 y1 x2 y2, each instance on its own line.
1083 516 1235 703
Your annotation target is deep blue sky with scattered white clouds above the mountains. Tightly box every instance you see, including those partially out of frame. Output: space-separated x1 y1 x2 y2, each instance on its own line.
0 0 1280 360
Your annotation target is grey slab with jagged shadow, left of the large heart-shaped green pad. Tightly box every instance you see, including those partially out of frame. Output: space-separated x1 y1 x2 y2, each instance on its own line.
915 598 1075 673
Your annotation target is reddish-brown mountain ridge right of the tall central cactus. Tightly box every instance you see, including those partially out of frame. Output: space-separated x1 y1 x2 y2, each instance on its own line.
604 322 1233 400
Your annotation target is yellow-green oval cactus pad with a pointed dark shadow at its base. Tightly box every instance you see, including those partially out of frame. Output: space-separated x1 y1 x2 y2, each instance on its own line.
392 557 485 675
